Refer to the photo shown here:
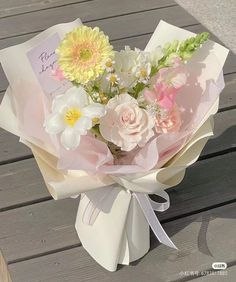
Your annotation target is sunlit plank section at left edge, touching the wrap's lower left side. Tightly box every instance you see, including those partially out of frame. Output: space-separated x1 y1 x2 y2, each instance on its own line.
0 159 51 211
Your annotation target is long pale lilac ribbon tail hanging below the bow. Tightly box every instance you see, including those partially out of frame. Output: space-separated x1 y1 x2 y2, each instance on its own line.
134 193 178 250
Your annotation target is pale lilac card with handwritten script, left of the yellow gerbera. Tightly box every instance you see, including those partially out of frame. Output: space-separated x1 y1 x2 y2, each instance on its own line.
27 34 71 97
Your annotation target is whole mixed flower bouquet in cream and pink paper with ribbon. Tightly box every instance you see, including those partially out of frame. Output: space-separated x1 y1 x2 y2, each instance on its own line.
0 20 228 271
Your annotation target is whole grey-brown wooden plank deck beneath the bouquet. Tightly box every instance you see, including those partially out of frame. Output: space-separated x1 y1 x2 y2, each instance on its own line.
0 0 236 282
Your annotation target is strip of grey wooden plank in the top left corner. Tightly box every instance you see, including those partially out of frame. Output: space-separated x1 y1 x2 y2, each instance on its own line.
0 0 94 18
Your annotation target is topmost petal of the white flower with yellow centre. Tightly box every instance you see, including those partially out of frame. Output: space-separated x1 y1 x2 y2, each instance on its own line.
65 86 88 108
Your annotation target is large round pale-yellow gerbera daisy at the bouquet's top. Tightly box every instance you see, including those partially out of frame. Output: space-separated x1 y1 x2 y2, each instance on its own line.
56 25 114 84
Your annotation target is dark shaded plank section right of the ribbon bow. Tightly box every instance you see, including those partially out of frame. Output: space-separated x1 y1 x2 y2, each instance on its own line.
160 152 236 221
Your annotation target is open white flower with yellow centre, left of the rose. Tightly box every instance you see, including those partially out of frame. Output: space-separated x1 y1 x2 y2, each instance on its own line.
44 87 105 150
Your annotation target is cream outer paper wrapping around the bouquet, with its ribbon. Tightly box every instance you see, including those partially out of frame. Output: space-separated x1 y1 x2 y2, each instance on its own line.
0 20 228 271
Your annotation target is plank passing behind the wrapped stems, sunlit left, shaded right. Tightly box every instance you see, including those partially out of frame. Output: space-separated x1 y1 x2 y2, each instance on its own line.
0 153 236 261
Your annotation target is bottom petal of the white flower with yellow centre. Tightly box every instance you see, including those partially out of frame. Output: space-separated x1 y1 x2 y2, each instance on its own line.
61 127 80 150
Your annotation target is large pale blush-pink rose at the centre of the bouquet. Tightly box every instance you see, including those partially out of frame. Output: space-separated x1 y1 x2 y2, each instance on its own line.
100 94 155 151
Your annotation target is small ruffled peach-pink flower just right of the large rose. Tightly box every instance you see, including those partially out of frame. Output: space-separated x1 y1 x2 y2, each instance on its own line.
155 104 182 133
